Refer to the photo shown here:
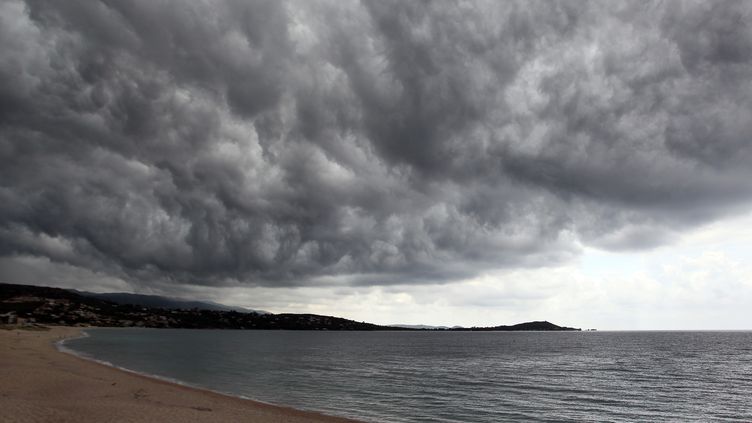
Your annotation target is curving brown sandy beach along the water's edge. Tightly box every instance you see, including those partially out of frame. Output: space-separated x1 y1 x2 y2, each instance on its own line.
0 327 364 423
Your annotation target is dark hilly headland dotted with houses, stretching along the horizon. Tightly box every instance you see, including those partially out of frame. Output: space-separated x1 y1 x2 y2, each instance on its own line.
0 284 580 331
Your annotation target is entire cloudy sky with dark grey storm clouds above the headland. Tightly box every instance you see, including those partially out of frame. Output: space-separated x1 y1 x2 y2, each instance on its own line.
0 0 752 329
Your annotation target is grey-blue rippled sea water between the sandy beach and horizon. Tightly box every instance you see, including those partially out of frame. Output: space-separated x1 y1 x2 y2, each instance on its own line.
65 329 752 422
